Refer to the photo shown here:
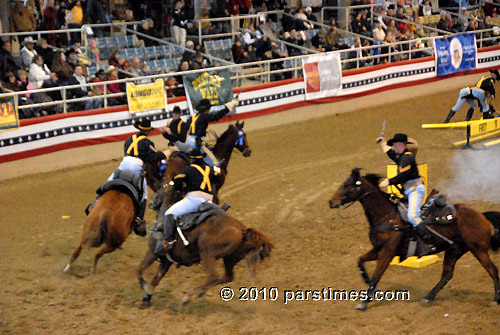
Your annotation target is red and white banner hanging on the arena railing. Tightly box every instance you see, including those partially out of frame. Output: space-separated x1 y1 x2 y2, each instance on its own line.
302 52 342 100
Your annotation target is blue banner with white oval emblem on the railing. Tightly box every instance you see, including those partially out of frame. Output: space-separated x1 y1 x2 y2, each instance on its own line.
434 33 477 76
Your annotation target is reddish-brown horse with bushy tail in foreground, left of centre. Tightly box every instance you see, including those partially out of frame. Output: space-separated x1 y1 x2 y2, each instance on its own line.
137 214 273 307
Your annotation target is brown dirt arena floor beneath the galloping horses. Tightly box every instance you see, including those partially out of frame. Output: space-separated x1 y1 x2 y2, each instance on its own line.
0 80 500 335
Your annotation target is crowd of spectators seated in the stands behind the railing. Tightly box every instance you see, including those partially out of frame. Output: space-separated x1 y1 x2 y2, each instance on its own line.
0 0 500 118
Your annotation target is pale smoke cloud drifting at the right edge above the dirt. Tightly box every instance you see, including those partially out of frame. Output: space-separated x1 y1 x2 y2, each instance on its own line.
439 145 500 204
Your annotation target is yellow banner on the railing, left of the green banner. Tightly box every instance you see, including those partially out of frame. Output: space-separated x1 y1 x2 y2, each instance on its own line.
127 79 166 113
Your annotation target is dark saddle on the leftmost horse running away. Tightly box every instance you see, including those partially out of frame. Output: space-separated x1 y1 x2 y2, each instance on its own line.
96 169 144 212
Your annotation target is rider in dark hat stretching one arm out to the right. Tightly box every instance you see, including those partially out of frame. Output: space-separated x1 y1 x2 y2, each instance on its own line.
181 98 238 166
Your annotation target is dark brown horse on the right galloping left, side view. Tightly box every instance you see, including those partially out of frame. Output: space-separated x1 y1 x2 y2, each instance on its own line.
329 169 500 310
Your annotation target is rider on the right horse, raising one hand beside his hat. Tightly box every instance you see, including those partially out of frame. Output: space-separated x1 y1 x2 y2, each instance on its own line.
377 134 429 247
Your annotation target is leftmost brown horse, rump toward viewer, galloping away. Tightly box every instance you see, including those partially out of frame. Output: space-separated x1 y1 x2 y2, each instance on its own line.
64 163 160 274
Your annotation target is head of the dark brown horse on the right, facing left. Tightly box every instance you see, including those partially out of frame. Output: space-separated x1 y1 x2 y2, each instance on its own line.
328 168 380 208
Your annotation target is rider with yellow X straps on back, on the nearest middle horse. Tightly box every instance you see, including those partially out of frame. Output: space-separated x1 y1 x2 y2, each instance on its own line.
154 149 219 254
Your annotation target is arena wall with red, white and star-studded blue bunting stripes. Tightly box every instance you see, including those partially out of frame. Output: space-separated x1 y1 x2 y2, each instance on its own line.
0 47 500 180
